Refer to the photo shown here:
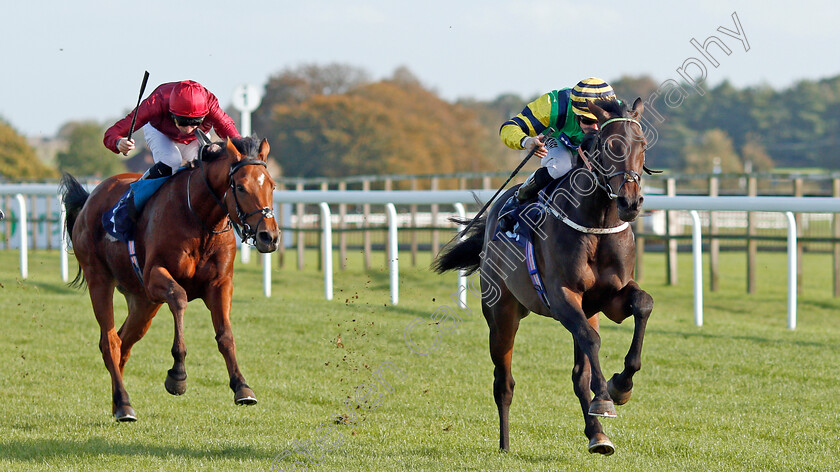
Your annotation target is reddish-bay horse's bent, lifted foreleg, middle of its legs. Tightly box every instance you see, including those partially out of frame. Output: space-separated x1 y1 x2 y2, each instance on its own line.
146 266 188 395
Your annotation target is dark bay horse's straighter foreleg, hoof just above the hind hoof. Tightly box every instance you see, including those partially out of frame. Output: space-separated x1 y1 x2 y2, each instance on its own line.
551 287 616 417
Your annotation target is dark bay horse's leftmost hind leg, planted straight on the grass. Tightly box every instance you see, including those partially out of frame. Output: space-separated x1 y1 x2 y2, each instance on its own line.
482 293 524 451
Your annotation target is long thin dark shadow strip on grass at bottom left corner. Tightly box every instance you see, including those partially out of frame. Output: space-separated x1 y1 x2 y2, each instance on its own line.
0 438 275 462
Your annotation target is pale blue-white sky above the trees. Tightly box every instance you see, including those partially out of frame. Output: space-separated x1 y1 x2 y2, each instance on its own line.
0 0 840 137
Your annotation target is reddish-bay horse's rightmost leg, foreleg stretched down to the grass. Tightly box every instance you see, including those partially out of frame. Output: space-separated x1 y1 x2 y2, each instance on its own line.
204 283 257 405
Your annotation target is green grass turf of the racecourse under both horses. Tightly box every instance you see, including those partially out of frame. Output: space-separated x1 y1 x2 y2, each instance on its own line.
0 247 840 471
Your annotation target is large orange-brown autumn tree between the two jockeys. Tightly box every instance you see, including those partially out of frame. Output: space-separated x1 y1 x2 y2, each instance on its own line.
263 67 490 177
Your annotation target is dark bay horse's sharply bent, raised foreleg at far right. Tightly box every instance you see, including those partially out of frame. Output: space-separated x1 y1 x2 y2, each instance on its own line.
604 281 653 405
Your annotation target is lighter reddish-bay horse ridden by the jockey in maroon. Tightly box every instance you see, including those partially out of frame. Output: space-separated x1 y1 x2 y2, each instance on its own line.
60 137 280 421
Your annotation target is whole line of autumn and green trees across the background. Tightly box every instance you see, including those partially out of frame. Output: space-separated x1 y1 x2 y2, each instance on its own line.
0 64 840 180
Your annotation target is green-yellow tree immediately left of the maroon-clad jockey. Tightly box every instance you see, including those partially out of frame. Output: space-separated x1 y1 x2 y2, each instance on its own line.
56 121 125 177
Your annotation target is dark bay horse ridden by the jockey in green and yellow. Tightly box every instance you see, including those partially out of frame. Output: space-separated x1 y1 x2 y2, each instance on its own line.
432 99 654 455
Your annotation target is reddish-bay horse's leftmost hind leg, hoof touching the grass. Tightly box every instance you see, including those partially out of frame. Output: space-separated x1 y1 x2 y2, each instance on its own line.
85 271 137 421
